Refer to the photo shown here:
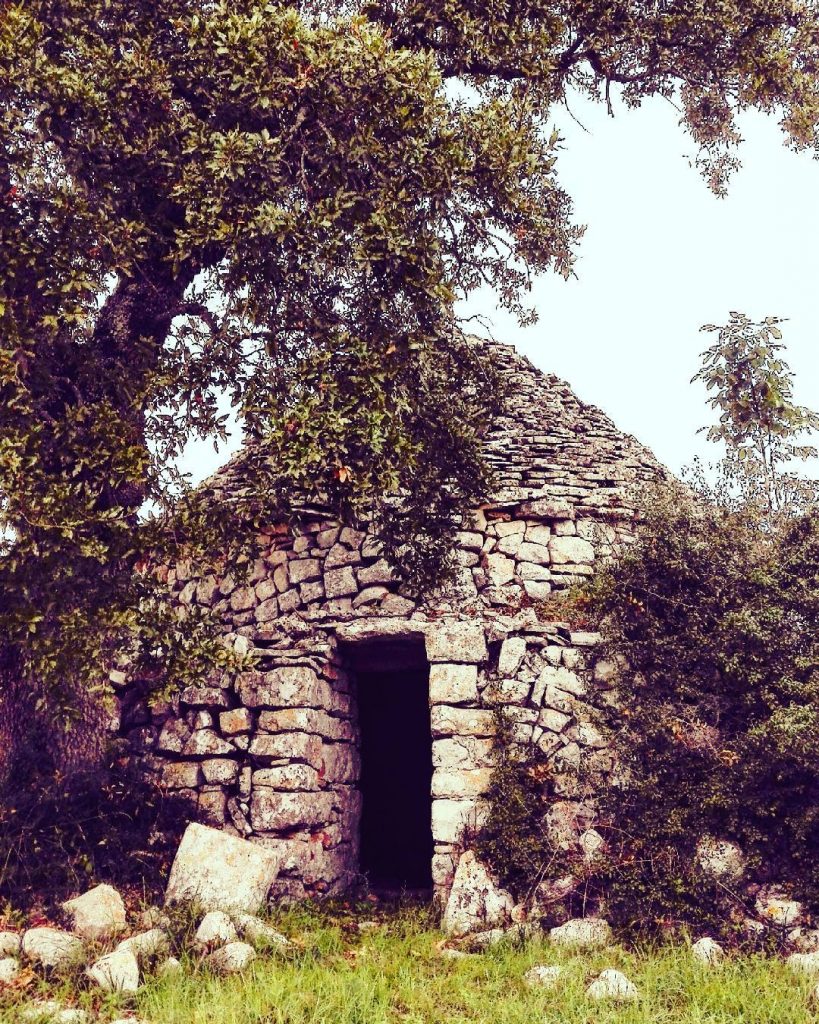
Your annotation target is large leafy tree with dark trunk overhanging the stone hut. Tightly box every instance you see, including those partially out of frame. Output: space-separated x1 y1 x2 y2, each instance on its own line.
0 0 819 770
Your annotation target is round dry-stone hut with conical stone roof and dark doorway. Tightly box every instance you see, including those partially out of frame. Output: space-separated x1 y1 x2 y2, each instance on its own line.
122 342 663 897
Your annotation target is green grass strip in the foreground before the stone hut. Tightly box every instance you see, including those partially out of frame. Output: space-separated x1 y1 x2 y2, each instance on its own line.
0 907 817 1024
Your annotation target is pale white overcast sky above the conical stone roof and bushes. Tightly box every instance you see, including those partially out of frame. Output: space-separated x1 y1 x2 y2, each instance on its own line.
184 91 819 479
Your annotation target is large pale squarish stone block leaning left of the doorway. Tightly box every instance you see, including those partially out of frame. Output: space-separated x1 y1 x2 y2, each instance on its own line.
165 822 279 912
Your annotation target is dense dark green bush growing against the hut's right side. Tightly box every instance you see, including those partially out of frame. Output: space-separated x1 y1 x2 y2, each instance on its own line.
581 484 819 928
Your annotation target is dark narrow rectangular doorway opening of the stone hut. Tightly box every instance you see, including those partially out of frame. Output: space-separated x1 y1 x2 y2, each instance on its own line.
355 643 433 890
